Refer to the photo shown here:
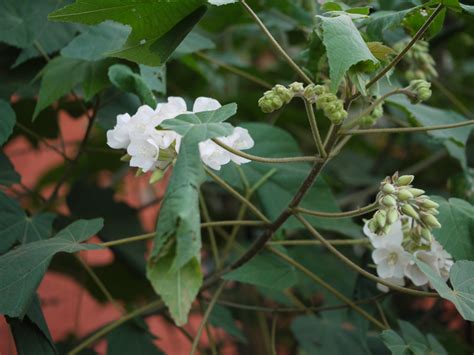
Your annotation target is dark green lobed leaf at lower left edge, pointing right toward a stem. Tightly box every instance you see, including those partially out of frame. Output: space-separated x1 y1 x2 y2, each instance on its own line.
0 219 103 317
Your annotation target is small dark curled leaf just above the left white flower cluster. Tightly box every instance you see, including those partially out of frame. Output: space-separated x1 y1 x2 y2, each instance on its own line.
109 64 156 108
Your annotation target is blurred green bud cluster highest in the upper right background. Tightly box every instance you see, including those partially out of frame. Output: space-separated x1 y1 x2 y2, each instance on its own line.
394 40 438 81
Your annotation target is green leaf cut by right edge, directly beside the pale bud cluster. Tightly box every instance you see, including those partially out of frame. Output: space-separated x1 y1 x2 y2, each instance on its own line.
433 196 474 260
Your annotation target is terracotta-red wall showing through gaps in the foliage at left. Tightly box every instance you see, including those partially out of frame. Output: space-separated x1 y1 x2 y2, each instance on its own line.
0 113 235 355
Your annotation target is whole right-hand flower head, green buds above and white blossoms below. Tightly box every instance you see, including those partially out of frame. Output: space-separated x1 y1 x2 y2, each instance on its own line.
364 174 453 291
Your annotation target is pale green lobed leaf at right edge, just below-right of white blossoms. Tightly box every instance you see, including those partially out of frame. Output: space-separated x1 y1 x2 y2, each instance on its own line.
413 258 474 322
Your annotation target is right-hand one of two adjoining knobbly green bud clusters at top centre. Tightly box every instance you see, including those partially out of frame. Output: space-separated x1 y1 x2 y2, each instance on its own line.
303 84 347 124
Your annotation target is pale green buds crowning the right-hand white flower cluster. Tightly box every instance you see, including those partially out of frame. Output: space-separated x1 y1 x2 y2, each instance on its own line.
368 173 441 240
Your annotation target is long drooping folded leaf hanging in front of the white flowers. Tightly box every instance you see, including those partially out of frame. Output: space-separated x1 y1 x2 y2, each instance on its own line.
147 104 236 325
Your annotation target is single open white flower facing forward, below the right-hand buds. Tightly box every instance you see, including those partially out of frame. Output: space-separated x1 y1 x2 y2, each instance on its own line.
372 244 410 279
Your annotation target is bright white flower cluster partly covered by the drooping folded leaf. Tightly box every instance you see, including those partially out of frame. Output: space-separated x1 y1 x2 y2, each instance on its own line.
107 97 254 172
